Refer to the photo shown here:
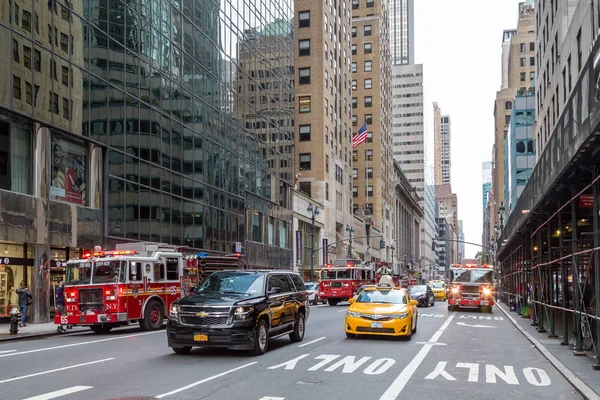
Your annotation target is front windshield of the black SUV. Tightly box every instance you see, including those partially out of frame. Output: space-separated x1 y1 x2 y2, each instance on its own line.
196 272 265 296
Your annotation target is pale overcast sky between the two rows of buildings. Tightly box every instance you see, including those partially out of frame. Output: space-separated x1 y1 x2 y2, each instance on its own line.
415 0 519 258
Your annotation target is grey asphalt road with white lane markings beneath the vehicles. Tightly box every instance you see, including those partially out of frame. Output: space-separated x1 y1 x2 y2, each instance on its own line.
0 302 580 400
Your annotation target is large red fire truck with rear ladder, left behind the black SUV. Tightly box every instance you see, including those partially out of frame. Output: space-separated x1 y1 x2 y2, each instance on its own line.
54 243 245 333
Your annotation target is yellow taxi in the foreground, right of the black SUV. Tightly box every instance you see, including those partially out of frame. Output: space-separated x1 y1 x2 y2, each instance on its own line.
345 286 418 339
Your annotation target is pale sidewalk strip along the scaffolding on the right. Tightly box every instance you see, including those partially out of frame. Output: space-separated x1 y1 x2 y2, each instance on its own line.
496 303 600 400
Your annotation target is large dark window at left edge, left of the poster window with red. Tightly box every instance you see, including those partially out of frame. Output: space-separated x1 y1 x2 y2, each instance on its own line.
0 114 33 194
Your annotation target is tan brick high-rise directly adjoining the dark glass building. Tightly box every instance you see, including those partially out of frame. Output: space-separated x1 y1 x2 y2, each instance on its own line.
294 0 354 265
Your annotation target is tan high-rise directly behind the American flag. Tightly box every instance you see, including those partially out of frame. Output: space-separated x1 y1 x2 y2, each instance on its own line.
351 0 394 260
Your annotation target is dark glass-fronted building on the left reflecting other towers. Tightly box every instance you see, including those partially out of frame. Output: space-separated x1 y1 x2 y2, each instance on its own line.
0 0 294 322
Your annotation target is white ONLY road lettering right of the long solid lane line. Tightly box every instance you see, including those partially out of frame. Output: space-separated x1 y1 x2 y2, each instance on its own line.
425 361 552 386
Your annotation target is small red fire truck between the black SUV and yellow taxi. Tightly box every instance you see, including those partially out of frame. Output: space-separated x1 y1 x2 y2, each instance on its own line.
319 260 375 306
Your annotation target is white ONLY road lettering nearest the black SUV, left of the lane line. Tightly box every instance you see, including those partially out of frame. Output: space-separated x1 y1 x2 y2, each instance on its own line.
267 354 396 375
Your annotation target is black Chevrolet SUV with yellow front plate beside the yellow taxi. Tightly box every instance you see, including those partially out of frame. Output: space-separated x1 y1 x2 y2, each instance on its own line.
167 270 309 355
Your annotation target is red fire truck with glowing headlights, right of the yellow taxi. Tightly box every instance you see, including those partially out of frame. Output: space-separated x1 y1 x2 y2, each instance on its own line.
448 264 494 312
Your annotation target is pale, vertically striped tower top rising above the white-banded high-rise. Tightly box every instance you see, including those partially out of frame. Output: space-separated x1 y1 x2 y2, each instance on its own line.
390 0 415 65
